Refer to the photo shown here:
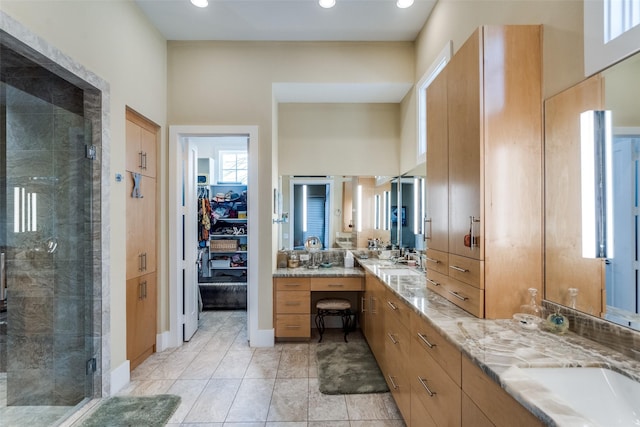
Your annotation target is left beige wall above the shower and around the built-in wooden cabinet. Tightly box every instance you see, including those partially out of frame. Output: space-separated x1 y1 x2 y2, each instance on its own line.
0 0 168 368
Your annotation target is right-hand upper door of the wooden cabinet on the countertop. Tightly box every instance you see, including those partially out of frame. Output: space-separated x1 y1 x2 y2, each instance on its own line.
447 29 483 259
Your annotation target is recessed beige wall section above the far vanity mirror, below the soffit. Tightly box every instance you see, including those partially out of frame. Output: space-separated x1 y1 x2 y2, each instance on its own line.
278 104 400 176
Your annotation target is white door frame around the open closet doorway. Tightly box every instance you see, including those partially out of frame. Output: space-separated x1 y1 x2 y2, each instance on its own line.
166 126 260 347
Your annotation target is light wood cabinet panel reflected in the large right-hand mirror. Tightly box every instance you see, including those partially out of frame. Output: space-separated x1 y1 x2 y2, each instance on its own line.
545 75 605 316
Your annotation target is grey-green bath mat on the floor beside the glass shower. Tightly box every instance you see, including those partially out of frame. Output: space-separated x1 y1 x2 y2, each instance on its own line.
80 394 180 427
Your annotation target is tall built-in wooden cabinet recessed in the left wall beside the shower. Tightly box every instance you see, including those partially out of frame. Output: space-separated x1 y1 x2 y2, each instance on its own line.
125 110 160 370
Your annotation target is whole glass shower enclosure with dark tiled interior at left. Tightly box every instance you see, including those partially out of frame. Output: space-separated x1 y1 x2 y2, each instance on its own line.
0 39 98 425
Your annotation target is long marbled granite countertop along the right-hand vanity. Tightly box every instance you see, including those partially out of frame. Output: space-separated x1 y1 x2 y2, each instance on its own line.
357 258 640 427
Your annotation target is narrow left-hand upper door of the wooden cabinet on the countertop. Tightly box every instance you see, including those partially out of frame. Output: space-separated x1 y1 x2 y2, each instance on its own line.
425 68 449 252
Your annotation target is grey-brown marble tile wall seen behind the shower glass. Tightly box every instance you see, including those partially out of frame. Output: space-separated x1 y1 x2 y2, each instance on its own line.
4 74 94 406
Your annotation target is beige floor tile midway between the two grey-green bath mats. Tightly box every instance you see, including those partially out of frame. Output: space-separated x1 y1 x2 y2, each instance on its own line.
226 378 275 422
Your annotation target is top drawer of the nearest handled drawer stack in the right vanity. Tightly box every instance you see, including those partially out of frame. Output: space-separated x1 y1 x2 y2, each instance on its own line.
411 313 462 386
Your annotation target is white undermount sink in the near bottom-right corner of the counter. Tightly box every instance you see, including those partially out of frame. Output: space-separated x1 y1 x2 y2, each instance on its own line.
522 368 640 426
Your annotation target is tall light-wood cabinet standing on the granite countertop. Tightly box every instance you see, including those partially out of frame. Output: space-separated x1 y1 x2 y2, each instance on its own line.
427 25 543 318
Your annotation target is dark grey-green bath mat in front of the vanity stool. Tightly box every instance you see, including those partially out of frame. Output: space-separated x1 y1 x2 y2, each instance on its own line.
316 341 389 394
